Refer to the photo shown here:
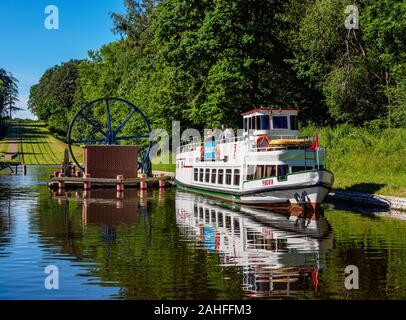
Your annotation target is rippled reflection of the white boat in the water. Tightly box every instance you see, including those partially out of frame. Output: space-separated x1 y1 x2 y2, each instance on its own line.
176 191 332 298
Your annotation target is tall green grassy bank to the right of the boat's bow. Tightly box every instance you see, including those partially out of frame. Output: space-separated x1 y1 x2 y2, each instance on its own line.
304 125 406 197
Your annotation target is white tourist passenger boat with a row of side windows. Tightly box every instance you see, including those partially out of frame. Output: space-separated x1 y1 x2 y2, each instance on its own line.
176 108 334 209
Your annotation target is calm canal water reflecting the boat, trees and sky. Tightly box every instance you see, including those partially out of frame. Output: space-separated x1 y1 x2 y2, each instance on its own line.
0 167 406 299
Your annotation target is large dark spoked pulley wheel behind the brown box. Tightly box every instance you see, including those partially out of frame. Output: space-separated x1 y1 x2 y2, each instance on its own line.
67 98 152 174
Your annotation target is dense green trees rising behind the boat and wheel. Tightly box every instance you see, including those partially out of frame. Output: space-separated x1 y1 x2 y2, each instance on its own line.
29 0 406 134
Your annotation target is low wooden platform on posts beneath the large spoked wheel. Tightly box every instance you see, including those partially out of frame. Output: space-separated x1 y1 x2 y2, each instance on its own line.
48 176 174 190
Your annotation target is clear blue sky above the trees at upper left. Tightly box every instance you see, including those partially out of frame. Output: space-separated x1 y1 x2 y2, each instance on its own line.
0 0 125 118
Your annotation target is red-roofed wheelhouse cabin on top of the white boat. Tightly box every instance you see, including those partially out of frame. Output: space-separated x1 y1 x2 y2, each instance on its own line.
242 108 299 138
